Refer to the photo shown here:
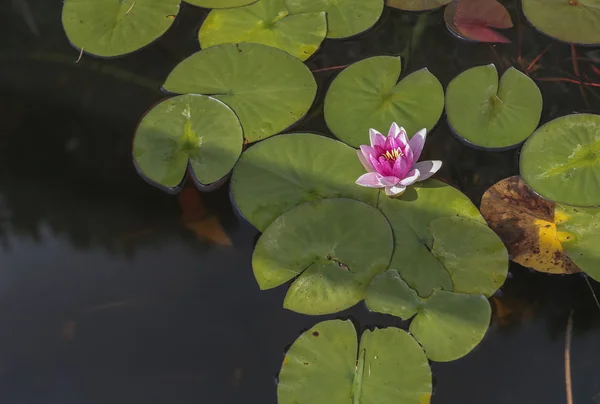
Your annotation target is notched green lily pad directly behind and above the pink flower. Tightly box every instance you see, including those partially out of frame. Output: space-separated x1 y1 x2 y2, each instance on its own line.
325 56 444 147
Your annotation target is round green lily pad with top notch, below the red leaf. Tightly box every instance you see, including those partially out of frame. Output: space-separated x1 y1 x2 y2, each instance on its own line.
446 64 542 150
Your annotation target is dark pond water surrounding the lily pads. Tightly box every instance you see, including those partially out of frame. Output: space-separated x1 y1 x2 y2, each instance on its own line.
0 0 600 404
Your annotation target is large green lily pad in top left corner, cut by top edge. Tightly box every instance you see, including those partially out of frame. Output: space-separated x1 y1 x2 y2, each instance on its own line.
62 0 180 57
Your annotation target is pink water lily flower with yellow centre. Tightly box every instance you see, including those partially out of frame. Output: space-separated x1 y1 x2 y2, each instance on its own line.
356 123 442 196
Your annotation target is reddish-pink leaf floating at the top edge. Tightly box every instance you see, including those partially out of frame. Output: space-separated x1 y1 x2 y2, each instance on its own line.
453 0 513 43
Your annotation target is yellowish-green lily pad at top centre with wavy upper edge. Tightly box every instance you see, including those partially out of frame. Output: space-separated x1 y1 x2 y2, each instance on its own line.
199 0 327 64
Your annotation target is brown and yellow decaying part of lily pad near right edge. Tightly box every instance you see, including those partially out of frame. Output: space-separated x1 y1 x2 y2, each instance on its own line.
481 176 581 274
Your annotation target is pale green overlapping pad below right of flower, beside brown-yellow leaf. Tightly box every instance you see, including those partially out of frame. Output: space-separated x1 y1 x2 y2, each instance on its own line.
429 217 508 297
